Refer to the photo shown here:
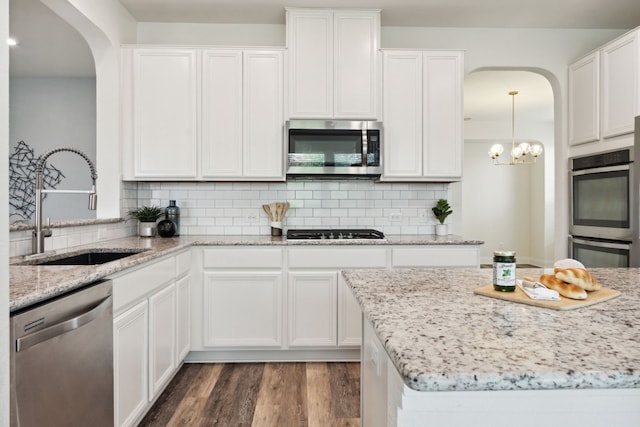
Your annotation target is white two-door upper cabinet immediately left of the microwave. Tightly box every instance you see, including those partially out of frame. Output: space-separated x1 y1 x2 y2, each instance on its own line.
201 50 284 180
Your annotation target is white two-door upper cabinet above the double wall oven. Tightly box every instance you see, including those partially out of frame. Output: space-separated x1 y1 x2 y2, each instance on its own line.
569 29 640 154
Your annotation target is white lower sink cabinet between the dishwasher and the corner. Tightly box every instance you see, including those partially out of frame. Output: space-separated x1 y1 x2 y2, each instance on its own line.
112 250 191 426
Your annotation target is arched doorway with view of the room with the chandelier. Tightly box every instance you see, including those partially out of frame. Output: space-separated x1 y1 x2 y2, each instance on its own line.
461 69 555 267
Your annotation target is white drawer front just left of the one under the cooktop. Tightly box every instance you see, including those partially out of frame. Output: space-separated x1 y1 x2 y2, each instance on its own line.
203 246 282 268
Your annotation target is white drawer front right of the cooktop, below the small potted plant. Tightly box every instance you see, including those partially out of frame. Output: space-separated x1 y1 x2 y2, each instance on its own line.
391 245 480 267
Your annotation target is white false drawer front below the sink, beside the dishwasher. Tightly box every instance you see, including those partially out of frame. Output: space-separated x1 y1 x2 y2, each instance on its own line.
113 257 176 313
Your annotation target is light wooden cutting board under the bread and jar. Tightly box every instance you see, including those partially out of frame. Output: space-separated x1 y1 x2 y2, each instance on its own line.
473 285 620 310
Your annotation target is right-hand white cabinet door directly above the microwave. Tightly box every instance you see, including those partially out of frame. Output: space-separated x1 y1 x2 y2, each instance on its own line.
333 11 380 119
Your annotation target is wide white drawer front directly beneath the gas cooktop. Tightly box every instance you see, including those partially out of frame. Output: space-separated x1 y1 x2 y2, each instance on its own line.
289 246 387 270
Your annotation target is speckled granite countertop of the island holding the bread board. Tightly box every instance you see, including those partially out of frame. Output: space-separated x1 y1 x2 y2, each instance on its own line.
343 269 640 391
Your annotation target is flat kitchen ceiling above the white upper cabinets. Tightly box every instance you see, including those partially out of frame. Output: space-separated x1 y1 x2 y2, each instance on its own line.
120 0 640 29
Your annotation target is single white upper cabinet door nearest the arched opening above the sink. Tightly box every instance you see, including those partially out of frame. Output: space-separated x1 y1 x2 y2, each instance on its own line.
133 49 197 178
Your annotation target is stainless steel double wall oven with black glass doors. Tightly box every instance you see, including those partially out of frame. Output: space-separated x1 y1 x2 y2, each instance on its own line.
569 140 640 267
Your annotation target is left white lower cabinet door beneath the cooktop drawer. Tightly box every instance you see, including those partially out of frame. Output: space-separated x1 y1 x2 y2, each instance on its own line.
288 272 338 347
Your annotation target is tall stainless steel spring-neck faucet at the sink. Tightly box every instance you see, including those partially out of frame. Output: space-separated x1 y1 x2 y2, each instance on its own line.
32 147 98 254
